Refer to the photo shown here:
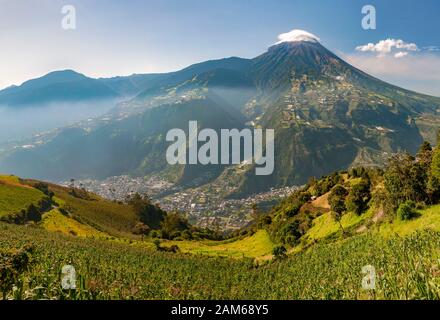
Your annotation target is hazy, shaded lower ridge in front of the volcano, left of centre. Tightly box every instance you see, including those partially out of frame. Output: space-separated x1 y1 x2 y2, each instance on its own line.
0 98 243 183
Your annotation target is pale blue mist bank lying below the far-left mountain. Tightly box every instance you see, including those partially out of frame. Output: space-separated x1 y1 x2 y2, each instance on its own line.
0 100 116 143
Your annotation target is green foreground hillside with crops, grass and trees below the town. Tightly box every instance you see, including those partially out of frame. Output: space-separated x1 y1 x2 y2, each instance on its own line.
0 145 440 300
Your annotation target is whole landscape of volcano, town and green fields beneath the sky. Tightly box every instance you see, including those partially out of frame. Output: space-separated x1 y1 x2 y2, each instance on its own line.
0 30 440 300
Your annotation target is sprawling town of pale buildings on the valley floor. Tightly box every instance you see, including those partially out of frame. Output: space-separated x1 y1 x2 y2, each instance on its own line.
62 175 297 230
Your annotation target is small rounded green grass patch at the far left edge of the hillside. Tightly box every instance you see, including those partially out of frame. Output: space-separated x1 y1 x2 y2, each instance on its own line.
0 175 44 217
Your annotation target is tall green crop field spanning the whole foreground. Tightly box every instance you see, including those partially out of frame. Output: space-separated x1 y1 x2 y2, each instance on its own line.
0 224 440 299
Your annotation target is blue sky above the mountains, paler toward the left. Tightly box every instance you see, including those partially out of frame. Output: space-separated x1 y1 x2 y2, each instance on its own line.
0 0 440 95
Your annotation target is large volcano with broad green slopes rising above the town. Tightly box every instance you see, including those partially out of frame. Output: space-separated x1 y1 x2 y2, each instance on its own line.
0 31 440 196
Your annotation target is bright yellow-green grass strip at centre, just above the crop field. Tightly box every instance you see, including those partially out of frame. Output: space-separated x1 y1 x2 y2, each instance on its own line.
164 230 274 258
